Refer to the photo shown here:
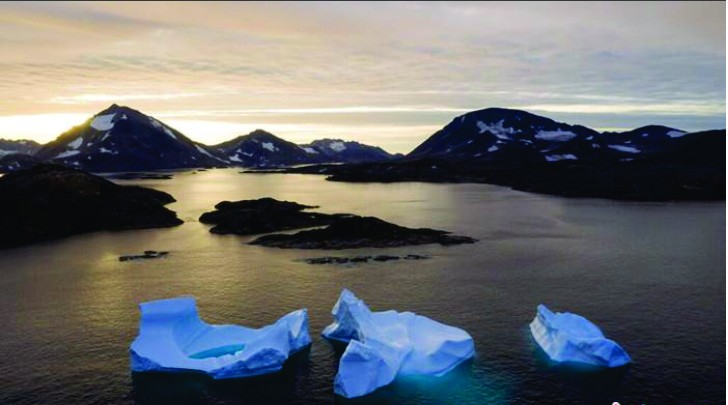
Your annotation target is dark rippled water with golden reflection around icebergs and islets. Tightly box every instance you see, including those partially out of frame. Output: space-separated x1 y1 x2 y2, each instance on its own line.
0 170 726 404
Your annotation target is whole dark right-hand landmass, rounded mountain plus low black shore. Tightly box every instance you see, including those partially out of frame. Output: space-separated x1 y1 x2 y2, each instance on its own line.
276 108 726 201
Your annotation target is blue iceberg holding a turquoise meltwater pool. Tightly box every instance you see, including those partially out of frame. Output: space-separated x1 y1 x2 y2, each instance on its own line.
130 297 311 379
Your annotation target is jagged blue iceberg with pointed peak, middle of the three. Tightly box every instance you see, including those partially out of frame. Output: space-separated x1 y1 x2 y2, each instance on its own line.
322 289 475 398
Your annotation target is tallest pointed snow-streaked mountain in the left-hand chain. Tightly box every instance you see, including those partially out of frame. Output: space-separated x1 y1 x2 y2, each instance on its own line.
35 104 224 172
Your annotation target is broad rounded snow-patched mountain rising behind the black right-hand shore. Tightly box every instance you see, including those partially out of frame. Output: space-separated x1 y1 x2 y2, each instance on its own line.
407 108 720 166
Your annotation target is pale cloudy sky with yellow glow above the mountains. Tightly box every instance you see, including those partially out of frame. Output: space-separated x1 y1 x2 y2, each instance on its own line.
0 2 726 152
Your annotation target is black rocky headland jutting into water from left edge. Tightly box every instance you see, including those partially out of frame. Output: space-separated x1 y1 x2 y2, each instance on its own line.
0 164 182 248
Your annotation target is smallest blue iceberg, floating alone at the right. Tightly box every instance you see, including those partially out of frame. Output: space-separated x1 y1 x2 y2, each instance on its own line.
531 304 632 367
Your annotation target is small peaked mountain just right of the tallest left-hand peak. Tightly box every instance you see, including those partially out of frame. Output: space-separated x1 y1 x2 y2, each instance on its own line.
210 129 313 167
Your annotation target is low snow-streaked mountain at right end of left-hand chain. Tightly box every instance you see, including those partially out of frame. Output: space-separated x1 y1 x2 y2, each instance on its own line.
301 139 393 163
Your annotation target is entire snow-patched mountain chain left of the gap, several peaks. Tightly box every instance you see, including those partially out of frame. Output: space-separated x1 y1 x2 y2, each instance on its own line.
7 104 392 172
